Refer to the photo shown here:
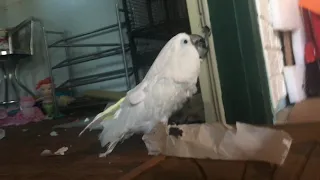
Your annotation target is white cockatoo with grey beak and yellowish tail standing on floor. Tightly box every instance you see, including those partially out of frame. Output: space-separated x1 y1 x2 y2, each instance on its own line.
80 33 208 156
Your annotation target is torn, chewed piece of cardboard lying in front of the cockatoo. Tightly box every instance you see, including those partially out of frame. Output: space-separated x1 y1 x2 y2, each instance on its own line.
142 123 292 165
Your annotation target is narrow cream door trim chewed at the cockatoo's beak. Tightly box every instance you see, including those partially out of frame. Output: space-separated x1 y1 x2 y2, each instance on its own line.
186 0 226 124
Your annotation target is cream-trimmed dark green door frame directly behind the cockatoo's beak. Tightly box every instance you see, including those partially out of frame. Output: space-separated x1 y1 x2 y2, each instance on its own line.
187 0 274 124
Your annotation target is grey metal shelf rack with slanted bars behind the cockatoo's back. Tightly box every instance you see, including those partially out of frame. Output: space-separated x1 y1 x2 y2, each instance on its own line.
47 23 132 90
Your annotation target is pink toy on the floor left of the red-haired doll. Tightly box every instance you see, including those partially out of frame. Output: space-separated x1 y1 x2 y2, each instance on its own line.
0 97 45 126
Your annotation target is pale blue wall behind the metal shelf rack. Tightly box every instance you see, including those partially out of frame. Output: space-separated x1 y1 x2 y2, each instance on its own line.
0 0 132 101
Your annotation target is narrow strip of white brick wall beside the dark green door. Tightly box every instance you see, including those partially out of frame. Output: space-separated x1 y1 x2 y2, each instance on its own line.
256 0 287 112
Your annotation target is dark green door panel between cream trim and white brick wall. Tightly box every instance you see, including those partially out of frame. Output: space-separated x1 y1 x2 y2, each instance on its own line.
207 0 273 124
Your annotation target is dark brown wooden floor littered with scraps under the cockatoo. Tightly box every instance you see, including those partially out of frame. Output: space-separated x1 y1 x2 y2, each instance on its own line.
0 121 320 180
